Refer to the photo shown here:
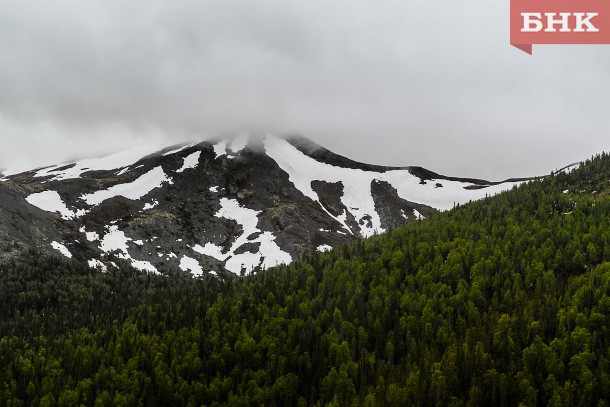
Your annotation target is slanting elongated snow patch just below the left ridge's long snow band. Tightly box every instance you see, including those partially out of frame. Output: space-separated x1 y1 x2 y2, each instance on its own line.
81 167 172 205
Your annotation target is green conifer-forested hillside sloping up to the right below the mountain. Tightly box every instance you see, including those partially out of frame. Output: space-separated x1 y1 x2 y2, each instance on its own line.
0 154 610 406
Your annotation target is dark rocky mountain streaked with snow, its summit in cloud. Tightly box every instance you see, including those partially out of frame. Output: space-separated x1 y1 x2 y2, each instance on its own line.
0 133 523 275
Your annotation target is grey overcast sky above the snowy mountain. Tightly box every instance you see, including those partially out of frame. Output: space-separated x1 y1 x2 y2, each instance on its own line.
0 0 610 179
